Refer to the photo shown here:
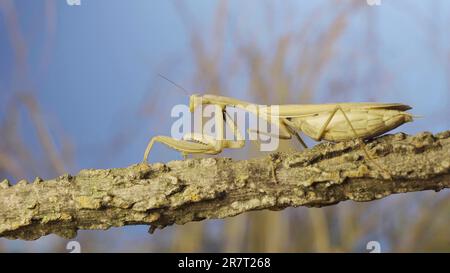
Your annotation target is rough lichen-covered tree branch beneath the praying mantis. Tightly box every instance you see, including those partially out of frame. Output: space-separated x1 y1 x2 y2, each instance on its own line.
0 131 450 240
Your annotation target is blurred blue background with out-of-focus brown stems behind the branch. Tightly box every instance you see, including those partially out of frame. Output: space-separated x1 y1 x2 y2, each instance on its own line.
0 0 450 252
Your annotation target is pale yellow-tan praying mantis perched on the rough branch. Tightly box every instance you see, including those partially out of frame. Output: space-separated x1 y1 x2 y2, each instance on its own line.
143 94 413 176
